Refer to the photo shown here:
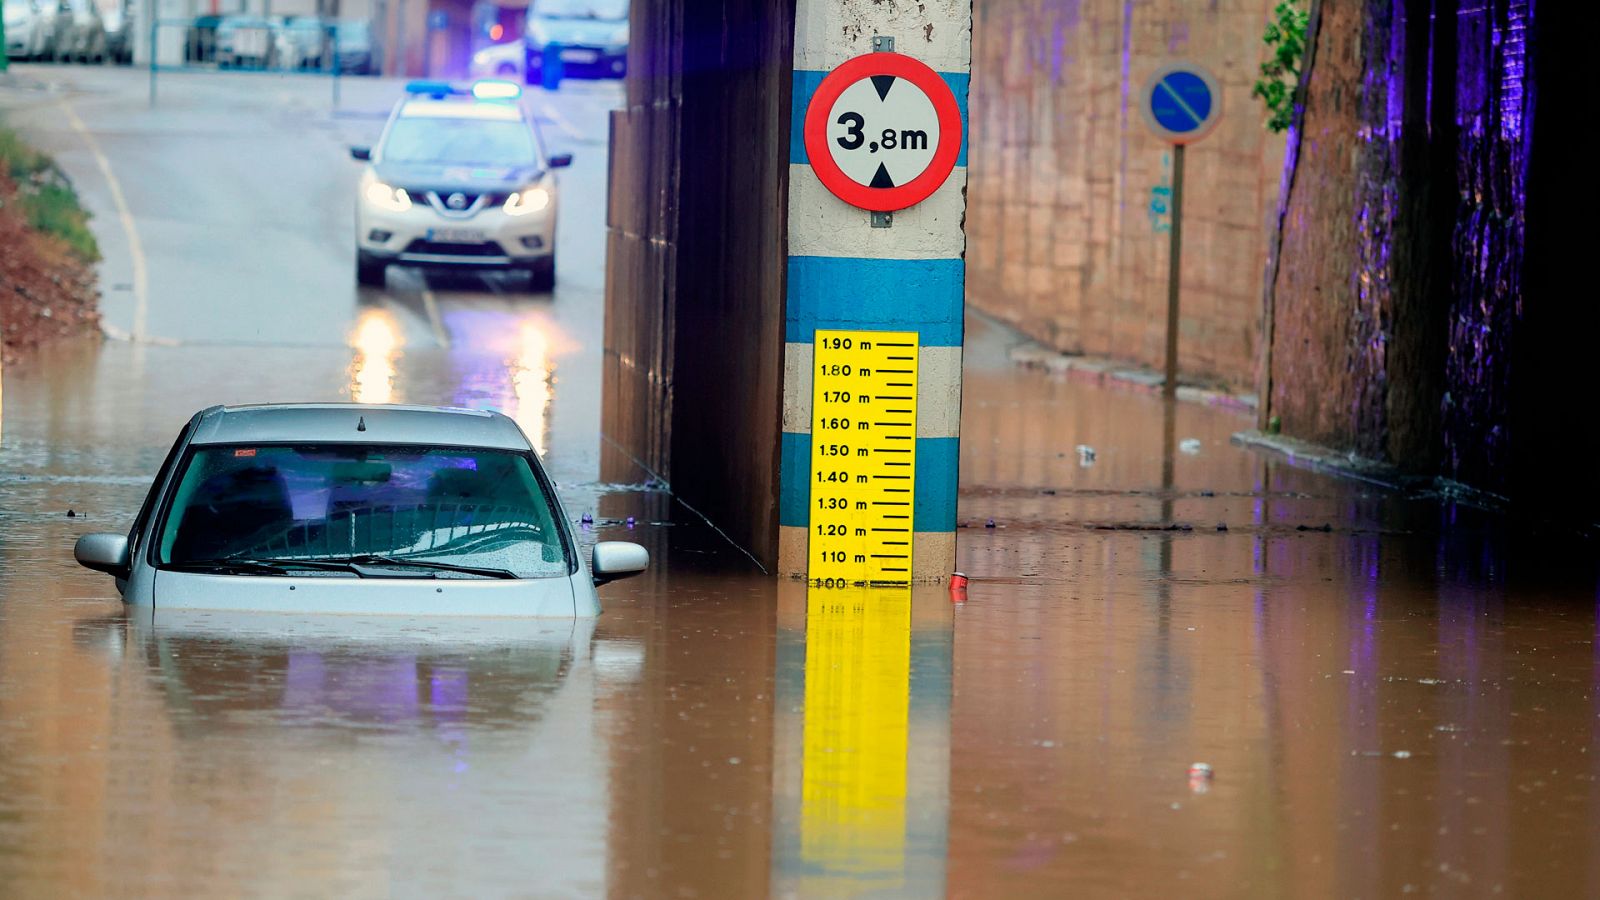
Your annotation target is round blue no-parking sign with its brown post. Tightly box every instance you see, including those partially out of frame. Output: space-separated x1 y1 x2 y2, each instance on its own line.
1141 62 1222 397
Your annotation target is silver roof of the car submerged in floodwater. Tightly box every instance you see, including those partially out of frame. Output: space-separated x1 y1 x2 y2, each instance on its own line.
190 404 530 452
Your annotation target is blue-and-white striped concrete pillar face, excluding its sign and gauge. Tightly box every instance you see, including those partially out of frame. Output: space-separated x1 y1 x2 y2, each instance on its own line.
779 0 971 581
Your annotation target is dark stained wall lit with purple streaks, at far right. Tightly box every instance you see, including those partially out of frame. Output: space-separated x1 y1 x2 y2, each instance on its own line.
1269 0 1600 506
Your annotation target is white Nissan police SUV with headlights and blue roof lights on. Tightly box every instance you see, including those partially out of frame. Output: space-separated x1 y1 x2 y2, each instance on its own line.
350 80 573 291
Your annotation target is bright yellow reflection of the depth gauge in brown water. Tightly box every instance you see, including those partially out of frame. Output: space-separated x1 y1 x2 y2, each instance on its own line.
800 588 910 895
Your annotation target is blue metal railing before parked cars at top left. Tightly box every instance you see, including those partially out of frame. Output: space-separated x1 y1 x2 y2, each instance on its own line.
149 18 376 107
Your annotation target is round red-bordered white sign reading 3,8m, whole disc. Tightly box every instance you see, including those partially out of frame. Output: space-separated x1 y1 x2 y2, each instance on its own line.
805 53 962 213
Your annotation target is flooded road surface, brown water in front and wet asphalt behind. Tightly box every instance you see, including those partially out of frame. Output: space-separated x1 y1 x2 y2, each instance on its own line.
0 67 1600 897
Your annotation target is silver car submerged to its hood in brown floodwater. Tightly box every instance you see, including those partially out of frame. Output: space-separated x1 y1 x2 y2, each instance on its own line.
75 404 650 617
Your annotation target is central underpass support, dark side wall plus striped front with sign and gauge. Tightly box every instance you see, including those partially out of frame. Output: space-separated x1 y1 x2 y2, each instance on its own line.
602 0 971 581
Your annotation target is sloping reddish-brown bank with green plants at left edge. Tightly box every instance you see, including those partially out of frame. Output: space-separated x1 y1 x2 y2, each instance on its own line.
0 125 101 362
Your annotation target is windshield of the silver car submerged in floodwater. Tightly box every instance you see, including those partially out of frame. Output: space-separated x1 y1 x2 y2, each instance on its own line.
157 444 571 578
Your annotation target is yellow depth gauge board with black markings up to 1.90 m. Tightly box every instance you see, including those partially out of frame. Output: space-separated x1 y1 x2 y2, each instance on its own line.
806 325 918 586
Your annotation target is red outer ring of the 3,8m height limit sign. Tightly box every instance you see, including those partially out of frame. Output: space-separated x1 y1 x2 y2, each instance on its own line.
805 53 962 213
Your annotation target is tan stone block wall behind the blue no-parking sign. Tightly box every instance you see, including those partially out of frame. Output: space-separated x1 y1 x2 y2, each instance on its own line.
966 0 1283 389
